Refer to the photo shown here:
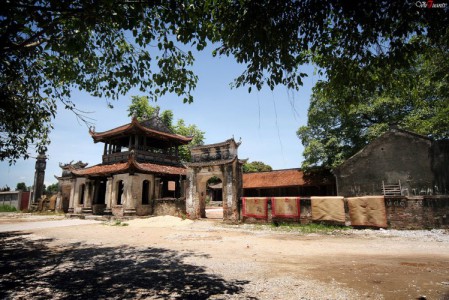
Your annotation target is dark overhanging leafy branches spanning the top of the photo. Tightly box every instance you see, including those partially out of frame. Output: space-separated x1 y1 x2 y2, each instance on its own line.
0 0 449 163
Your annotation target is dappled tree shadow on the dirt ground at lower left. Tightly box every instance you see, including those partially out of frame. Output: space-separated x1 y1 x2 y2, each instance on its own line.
0 233 249 299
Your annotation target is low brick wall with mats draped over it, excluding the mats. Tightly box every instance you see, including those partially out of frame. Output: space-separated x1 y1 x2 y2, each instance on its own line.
240 196 449 229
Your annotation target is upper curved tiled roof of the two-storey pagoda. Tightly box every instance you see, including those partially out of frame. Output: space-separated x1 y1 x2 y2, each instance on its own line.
89 118 192 144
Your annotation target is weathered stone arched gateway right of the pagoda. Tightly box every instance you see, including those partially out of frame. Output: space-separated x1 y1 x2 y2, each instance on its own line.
185 139 244 221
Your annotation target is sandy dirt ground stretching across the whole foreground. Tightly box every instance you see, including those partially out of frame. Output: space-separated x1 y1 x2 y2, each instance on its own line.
0 215 449 299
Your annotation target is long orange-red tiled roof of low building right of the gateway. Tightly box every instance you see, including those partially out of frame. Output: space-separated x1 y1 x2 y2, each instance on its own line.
243 169 333 189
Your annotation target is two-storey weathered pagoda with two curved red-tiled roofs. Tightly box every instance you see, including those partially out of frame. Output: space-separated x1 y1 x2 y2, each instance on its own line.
64 115 192 216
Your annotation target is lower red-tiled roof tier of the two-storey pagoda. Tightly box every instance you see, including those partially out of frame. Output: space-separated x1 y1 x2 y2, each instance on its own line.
72 159 186 176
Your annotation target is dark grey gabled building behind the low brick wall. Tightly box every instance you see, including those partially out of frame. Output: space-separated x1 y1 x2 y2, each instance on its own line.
333 128 449 196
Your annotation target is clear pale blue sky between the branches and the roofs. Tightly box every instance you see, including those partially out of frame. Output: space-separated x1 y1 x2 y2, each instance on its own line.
0 47 318 189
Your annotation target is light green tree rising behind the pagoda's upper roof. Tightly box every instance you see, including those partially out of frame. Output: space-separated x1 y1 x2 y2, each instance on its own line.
128 96 204 161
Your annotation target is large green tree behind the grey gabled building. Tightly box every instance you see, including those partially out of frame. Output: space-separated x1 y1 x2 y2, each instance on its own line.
297 47 449 170
